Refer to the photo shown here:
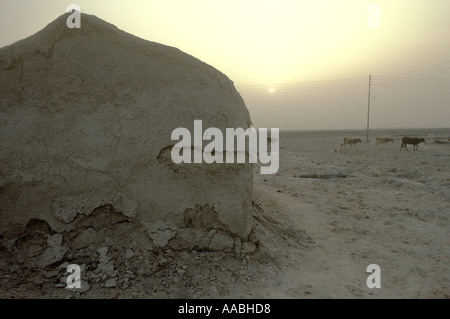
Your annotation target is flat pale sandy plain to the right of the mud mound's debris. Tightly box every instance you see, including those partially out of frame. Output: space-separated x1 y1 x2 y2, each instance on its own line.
250 134 450 298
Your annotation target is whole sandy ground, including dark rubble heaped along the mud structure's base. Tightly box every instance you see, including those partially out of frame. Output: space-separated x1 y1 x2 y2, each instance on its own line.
0 133 450 298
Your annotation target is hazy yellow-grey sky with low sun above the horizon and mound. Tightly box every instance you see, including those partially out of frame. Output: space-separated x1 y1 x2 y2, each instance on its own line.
0 0 450 130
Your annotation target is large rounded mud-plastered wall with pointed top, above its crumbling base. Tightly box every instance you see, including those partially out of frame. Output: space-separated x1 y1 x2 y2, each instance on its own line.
0 13 253 239
